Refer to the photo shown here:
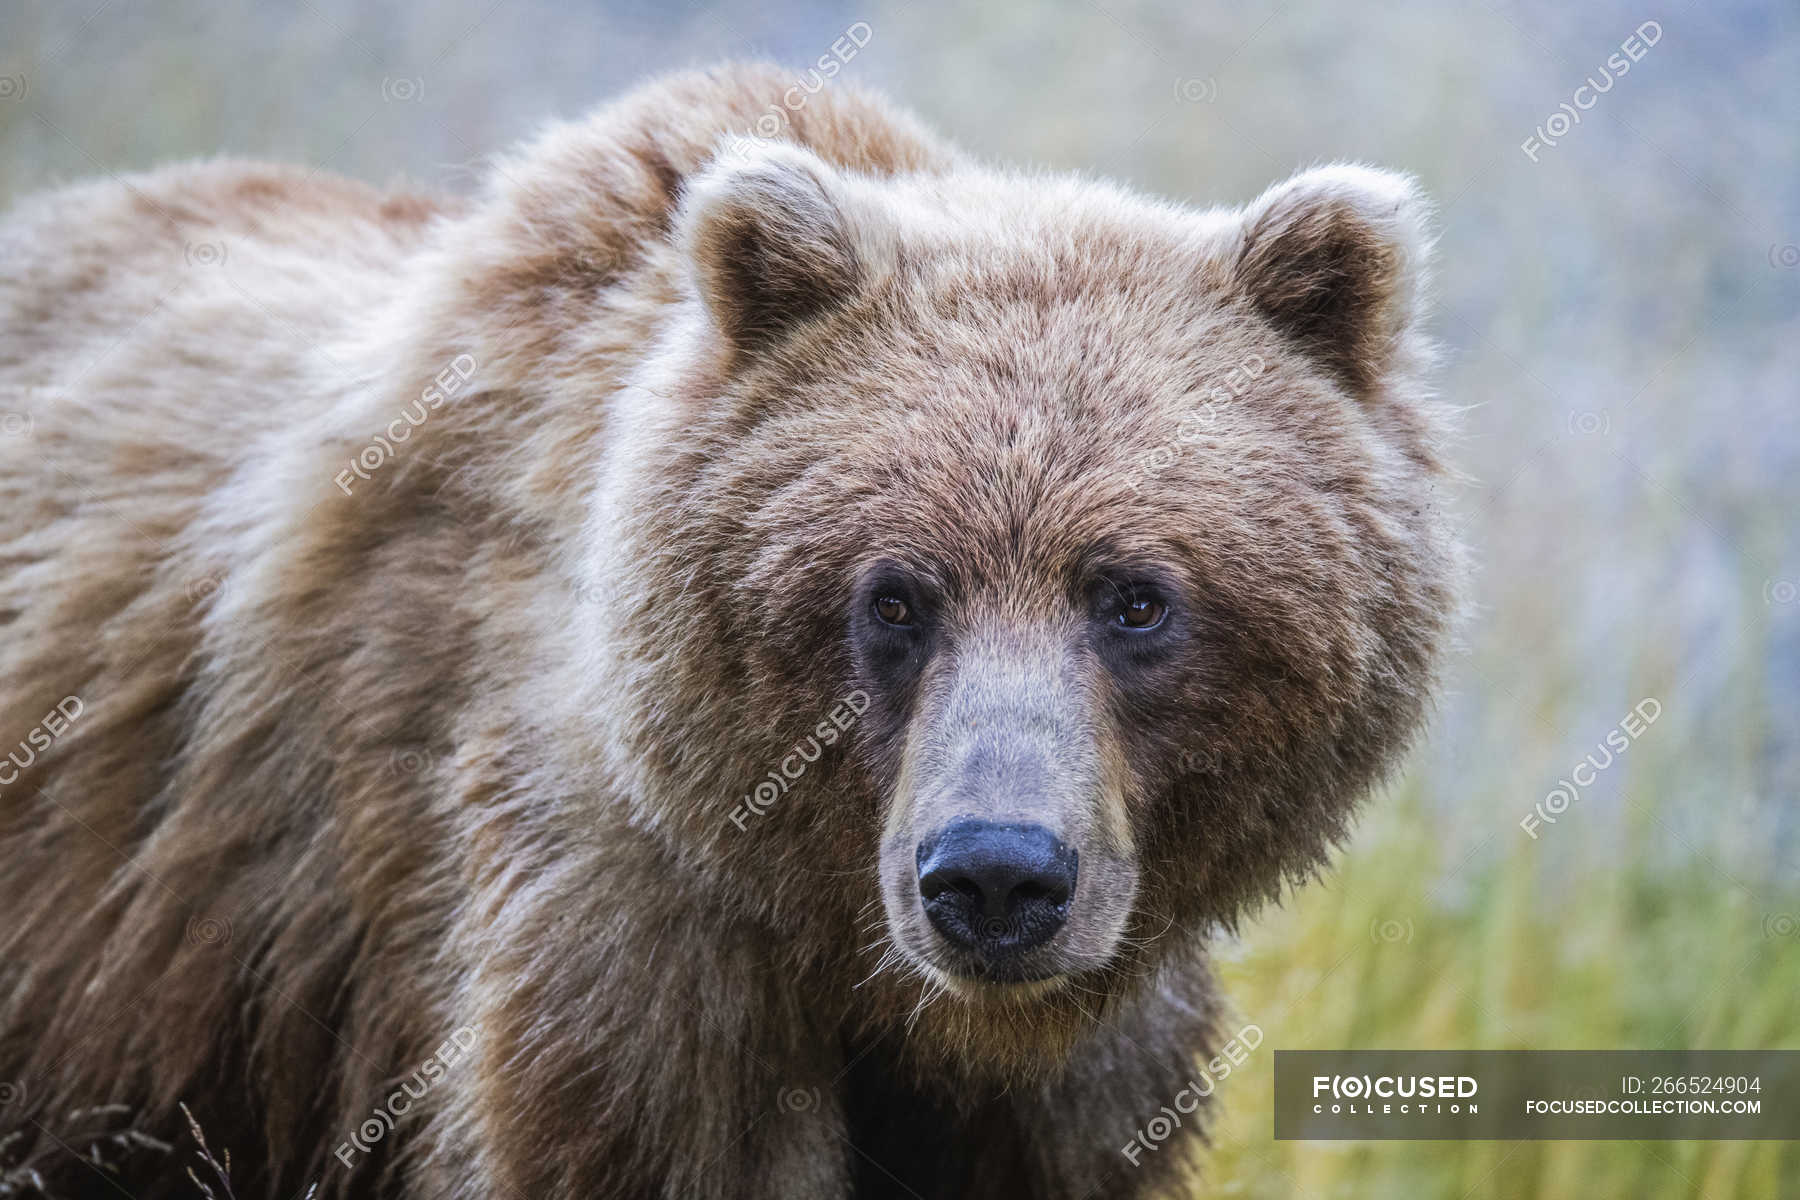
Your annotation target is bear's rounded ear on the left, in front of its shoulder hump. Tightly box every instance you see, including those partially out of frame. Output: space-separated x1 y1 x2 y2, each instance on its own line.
677 139 864 349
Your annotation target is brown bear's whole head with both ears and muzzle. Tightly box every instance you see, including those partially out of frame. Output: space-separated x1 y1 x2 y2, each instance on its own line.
603 144 1454 1057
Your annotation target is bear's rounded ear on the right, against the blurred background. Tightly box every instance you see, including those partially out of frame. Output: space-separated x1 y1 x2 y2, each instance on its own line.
1233 166 1429 396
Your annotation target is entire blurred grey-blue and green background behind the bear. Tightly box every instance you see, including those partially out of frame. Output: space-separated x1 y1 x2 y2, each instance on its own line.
0 0 1800 1200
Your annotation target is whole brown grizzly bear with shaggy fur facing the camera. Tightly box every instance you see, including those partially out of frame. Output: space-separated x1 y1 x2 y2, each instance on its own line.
0 67 1460 1200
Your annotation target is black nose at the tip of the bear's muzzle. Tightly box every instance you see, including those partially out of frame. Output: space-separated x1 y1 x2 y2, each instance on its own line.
918 819 1075 961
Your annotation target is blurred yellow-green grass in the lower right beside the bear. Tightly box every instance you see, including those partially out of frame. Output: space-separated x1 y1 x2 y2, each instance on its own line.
1197 784 1800 1200
